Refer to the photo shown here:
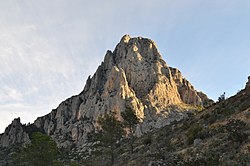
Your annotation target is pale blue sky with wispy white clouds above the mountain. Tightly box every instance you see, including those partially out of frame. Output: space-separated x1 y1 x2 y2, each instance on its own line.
0 0 250 132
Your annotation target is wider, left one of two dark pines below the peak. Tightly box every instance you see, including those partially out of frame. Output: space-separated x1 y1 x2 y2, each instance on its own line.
97 113 124 165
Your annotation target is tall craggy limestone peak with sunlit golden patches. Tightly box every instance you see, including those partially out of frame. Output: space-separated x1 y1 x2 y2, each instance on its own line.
0 35 210 147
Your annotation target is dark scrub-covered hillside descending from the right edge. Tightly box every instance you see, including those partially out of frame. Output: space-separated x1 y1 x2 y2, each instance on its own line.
84 77 250 166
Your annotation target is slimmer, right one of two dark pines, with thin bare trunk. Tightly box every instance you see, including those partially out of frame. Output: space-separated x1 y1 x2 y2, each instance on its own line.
121 107 139 153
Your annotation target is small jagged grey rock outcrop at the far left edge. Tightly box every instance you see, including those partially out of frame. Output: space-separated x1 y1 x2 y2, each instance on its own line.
0 118 30 147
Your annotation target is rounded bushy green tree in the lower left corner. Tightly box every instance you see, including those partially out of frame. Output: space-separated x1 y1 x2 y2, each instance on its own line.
18 132 58 166
